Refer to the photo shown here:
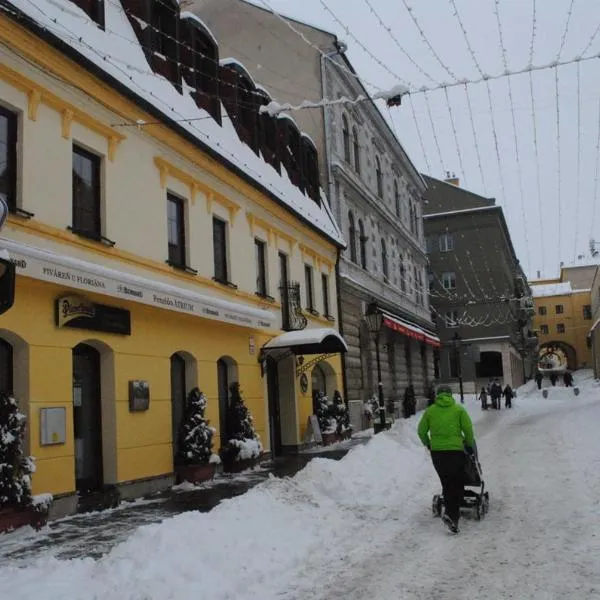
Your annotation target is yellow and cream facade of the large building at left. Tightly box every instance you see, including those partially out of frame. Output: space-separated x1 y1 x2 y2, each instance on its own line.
0 3 345 514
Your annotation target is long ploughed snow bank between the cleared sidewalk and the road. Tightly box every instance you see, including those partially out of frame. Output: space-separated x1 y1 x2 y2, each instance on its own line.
0 419 430 600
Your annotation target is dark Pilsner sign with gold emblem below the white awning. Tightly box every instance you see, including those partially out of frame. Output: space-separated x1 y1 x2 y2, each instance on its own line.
56 294 131 335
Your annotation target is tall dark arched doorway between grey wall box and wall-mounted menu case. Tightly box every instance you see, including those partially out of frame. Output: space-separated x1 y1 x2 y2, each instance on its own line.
73 344 103 493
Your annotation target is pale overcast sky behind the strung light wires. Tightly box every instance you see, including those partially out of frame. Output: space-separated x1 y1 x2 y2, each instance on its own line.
245 0 600 277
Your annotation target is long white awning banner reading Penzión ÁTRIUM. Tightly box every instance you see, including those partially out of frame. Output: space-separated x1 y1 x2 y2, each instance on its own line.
7 239 274 329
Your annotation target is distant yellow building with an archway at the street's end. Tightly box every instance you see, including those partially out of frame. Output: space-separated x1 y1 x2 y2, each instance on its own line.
530 266 596 370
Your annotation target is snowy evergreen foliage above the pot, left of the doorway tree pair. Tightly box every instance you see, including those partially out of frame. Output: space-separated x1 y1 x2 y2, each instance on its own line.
177 388 220 465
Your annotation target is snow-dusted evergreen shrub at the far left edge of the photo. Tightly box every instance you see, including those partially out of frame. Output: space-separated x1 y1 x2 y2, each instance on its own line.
0 393 35 508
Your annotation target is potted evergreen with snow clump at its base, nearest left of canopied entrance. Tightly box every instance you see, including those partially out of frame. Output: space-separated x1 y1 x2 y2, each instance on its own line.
221 382 263 472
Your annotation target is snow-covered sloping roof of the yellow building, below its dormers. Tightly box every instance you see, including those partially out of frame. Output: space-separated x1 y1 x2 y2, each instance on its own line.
2 0 344 245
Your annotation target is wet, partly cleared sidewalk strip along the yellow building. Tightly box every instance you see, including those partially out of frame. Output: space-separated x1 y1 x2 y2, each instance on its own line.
0 438 366 564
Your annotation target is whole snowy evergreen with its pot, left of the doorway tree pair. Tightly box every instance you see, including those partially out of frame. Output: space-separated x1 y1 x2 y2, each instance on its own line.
175 387 221 483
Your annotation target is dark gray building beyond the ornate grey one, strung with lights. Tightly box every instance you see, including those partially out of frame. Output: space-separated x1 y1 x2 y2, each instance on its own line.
423 176 537 393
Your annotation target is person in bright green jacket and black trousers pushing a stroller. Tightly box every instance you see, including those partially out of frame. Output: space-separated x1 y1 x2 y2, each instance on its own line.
417 385 475 533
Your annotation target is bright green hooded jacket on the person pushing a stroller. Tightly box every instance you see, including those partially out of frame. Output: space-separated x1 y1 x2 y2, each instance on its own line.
417 392 475 451
